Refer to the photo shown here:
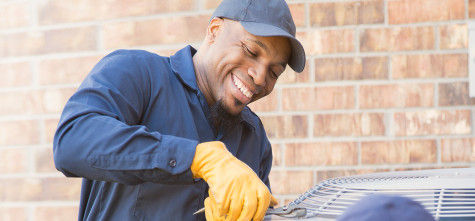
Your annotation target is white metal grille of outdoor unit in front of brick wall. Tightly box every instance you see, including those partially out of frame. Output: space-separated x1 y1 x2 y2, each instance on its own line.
268 168 475 219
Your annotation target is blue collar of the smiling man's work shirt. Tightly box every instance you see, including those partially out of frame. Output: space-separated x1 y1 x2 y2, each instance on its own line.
170 45 257 129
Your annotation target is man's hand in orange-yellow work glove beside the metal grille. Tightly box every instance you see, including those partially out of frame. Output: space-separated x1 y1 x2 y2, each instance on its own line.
191 141 277 221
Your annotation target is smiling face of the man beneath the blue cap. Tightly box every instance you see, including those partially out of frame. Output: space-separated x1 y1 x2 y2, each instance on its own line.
206 18 291 115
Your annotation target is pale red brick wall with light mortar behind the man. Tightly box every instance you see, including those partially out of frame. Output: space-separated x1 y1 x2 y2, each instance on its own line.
0 0 475 220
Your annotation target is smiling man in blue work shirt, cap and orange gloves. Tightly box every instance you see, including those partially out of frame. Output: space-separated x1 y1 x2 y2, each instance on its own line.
54 0 305 220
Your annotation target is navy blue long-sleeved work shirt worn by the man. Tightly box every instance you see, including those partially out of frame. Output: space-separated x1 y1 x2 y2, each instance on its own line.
53 46 272 220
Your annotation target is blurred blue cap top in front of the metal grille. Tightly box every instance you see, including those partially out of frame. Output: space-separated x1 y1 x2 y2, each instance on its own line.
337 194 434 221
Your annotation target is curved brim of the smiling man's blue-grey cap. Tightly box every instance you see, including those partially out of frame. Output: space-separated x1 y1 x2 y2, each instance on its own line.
240 21 305 73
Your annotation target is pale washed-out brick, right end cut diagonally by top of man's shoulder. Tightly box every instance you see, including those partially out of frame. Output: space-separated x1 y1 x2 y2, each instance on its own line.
39 56 100 85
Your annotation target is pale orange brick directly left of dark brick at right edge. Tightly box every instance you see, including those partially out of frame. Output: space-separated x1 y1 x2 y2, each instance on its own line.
359 83 434 108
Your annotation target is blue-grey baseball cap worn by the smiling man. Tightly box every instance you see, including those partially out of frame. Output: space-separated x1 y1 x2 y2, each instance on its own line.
211 0 305 73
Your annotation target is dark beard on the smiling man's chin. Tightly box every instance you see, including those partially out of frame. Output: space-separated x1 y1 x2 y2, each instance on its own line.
209 100 241 131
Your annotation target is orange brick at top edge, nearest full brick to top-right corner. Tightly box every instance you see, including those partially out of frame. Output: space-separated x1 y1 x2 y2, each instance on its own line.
388 0 465 24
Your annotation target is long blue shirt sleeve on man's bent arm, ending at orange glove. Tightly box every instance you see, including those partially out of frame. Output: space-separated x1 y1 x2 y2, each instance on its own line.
53 50 198 184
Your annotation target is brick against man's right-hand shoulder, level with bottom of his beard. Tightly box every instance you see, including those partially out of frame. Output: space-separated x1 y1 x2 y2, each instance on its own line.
261 115 308 138
